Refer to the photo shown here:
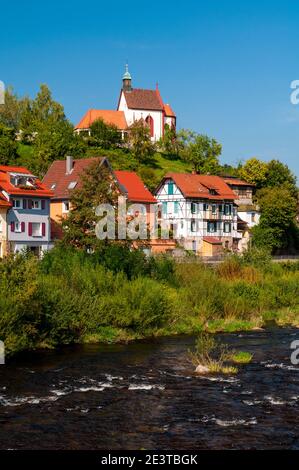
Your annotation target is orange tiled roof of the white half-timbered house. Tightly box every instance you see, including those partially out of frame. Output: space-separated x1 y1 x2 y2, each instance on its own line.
164 173 238 200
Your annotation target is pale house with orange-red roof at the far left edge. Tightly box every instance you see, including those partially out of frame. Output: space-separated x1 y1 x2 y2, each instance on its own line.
0 166 52 256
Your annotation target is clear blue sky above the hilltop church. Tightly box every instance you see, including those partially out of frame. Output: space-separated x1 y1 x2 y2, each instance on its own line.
0 0 299 176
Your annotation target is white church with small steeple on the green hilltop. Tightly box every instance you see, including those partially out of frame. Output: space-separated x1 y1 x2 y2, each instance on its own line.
75 65 176 142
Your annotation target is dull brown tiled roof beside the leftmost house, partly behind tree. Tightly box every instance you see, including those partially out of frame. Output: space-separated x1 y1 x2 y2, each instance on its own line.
43 157 105 199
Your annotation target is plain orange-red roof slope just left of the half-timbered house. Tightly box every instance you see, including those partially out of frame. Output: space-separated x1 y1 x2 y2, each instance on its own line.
114 171 157 203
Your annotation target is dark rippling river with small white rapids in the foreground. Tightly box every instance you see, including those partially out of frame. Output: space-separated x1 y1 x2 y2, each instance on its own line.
0 329 299 450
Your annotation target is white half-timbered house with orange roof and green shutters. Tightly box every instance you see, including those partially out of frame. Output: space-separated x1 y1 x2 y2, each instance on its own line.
155 173 241 256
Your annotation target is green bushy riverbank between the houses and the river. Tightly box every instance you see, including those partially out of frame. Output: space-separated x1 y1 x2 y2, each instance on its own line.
0 245 299 356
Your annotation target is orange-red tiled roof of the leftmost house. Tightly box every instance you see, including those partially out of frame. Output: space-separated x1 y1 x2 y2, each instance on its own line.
0 165 53 197
